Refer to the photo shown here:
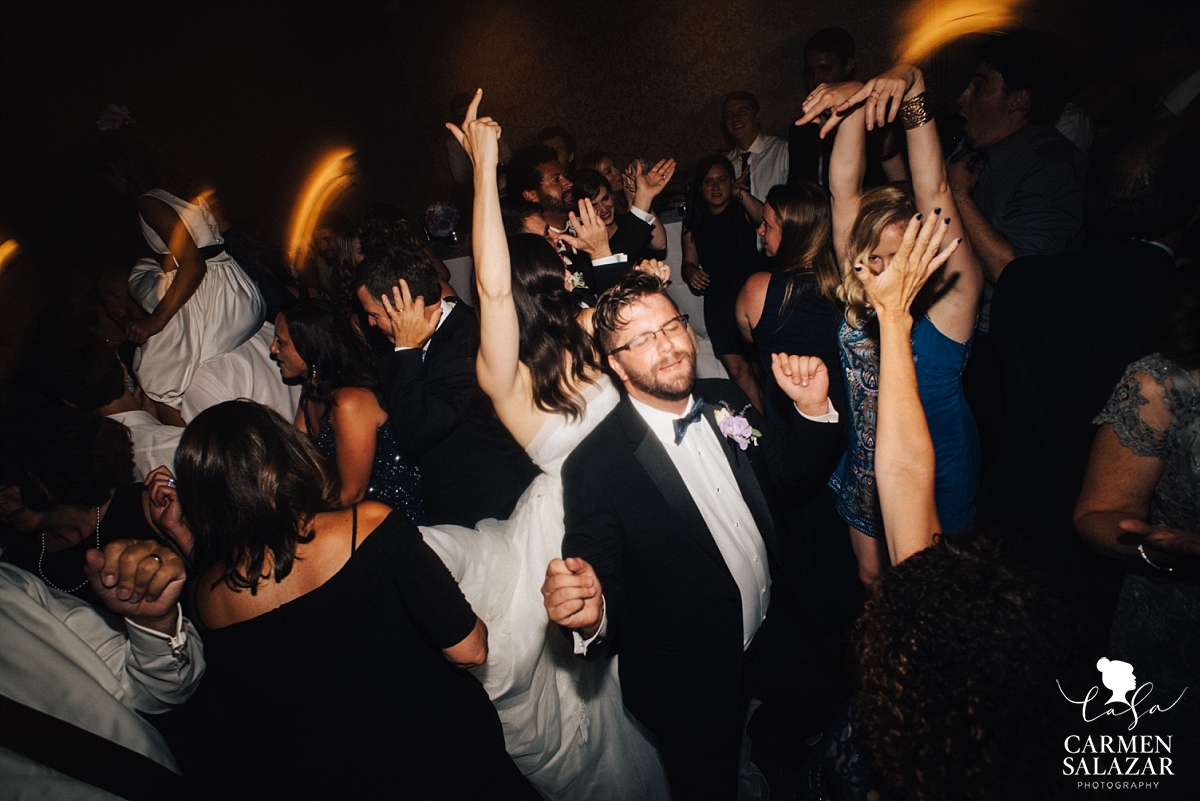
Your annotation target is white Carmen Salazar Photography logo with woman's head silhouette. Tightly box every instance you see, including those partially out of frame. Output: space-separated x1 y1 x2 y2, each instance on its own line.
1056 657 1187 789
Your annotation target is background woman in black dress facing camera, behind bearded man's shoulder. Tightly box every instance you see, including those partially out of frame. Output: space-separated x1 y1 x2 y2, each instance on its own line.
680 156 763 411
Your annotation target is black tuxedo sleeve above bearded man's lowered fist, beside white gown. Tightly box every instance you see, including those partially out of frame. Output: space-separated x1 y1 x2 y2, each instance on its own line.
563 456 623 661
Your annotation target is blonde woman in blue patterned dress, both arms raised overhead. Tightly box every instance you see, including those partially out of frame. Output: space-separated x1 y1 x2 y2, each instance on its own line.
797 65 983 585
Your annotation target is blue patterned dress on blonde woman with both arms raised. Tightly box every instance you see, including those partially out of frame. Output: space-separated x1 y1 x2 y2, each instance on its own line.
829 317 979 537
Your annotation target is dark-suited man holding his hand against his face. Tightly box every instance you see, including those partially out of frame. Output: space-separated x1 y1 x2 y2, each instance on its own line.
355 245 538 528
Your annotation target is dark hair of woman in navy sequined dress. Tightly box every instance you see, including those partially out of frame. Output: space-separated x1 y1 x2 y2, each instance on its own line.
283 299 384 436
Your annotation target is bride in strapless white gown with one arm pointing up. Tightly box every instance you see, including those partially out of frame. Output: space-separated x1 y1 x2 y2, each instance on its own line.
421 90 670 800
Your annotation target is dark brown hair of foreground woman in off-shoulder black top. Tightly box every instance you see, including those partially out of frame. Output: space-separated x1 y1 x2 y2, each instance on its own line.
175 401 340 595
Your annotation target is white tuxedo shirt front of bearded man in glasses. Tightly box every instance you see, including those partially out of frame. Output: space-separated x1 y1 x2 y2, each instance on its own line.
630 397 770 649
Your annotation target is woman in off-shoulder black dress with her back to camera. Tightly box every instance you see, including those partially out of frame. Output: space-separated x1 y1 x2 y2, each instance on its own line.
141 402 538 799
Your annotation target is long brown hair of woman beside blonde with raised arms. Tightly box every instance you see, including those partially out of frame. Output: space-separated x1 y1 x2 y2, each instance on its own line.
767 181 842 316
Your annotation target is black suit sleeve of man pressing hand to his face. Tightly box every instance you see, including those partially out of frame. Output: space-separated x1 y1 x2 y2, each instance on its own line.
379 308 479 454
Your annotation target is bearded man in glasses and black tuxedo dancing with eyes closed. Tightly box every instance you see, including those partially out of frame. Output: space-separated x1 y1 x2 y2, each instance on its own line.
542 272 844 799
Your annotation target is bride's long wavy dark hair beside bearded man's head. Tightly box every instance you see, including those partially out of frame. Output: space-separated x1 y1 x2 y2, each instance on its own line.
509 234 600 418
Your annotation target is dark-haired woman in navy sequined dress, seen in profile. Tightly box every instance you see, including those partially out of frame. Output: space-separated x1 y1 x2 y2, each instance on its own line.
271 300 425 525
